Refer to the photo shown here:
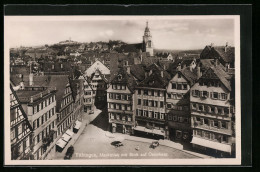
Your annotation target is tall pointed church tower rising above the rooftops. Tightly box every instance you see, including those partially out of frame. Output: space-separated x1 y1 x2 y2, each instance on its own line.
143 22 153 56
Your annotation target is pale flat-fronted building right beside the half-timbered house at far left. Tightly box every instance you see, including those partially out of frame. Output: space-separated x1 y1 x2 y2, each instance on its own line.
16 87 57 160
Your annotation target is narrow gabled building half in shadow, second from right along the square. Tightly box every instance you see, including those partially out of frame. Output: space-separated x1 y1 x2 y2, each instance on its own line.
166 66 198 142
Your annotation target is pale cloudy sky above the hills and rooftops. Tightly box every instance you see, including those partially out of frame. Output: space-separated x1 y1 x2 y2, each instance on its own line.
5 17 234 50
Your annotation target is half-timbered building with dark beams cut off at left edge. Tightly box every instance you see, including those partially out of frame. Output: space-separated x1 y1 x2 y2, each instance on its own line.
10 85 34 160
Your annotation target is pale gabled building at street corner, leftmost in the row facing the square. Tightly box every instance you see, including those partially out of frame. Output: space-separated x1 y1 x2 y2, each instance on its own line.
107 66 136 134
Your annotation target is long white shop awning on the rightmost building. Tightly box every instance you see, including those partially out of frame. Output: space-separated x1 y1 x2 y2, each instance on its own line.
191 137 231 153
